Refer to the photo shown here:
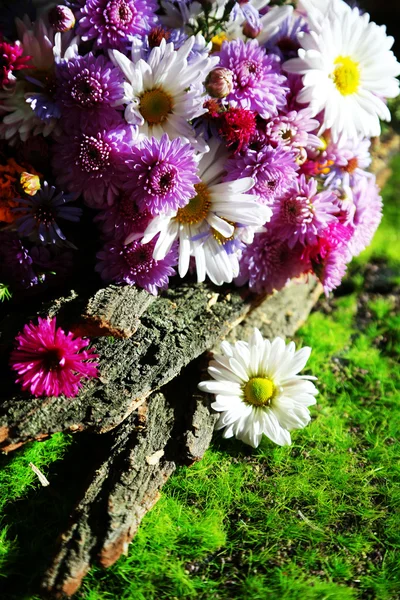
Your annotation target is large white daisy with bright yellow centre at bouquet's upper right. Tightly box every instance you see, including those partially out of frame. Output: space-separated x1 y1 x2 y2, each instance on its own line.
284 2 400 140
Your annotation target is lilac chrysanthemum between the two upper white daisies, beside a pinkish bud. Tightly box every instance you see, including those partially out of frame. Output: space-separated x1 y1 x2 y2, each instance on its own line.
219 40 288 119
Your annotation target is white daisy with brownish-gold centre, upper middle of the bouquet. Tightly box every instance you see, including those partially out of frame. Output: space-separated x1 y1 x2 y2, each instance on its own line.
110 36 219 144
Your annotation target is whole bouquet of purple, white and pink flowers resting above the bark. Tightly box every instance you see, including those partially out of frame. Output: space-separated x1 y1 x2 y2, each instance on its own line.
0 0 400 393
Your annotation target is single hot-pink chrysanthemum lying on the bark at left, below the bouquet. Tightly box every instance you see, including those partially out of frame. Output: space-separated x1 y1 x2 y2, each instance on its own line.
10 317 98 398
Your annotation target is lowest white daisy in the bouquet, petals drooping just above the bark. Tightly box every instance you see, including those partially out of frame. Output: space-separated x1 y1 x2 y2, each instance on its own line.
138 142 272 285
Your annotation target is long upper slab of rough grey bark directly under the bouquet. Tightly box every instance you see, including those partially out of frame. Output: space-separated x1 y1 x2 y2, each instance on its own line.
0 279 317 451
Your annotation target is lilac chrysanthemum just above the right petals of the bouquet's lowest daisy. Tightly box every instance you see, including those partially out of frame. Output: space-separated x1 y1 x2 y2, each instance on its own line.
226 146 299 204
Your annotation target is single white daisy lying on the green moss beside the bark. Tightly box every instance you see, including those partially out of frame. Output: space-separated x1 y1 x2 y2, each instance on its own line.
199 329 318 448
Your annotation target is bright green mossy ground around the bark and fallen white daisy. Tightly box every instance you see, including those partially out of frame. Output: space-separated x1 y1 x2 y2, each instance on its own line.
0 157 400 600
